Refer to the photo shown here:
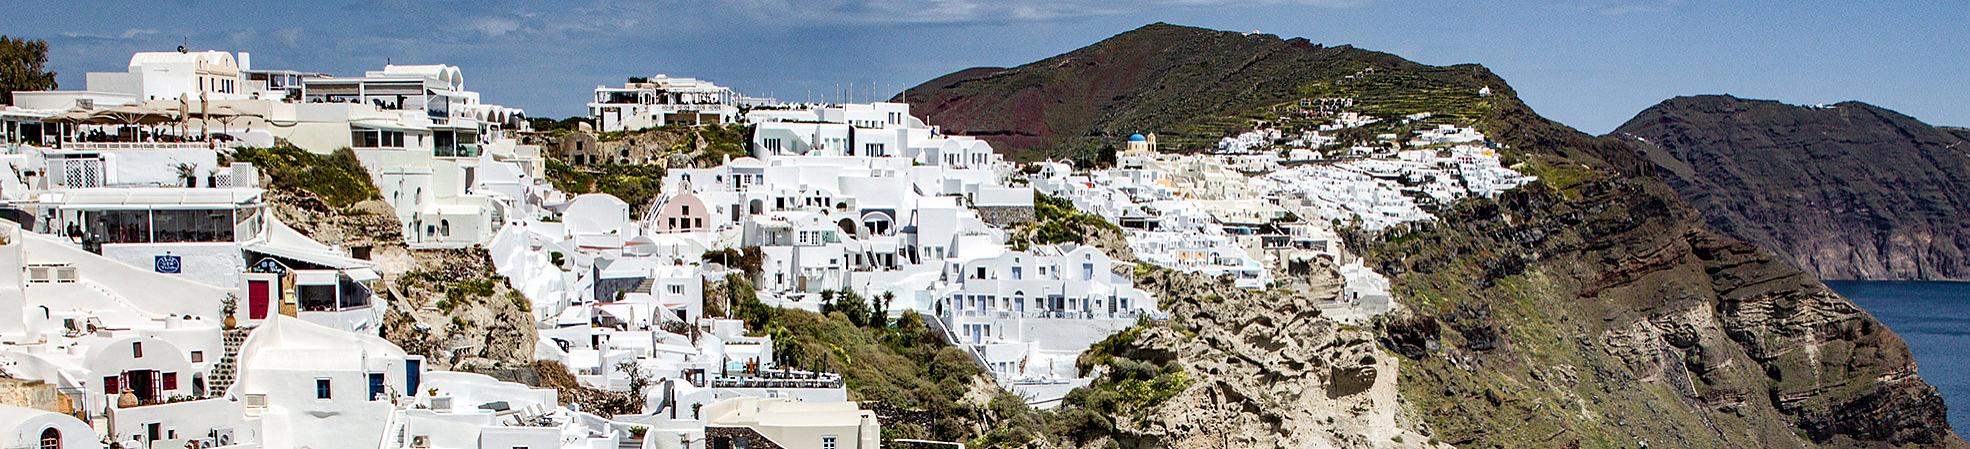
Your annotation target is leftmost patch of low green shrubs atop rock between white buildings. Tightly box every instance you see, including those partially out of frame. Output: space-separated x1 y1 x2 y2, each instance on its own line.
232 146 378 207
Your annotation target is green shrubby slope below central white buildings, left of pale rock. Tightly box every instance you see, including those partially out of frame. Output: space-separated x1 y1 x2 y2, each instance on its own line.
707 269 1194 447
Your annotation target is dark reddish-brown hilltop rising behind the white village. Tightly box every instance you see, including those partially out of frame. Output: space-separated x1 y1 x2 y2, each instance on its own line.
900 24 1449 160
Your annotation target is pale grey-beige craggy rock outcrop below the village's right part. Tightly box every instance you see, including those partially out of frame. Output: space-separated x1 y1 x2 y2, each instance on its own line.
1087 266 1432 447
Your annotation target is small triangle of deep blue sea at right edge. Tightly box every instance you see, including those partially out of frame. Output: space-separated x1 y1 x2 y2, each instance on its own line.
1826 282 1970 435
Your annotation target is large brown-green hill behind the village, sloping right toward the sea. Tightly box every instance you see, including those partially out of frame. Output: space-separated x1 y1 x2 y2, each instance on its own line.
908 24 1964 447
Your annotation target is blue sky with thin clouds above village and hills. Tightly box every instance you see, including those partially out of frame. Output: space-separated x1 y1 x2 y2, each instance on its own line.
0 0 1970 134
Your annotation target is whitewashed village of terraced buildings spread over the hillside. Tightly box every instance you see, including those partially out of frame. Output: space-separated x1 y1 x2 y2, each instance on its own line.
0 49 1533 449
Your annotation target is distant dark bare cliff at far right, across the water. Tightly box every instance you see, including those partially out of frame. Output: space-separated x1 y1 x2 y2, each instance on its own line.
1613 96 1970 280
